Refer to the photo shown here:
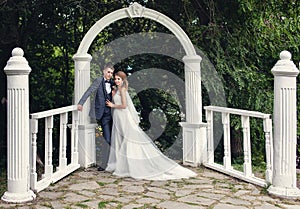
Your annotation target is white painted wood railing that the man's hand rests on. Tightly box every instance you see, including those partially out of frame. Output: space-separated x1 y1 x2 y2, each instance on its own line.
30 105 80 192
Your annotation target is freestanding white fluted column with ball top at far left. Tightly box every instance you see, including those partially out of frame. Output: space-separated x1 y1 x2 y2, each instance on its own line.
2 48 35 203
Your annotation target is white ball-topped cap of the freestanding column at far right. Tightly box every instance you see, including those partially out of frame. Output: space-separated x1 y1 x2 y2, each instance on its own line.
271 51 299 77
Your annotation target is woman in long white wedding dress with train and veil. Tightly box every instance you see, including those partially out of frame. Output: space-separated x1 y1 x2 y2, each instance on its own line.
106 71 197 180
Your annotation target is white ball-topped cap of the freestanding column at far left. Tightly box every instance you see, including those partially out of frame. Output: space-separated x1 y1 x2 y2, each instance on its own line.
4 47 31 75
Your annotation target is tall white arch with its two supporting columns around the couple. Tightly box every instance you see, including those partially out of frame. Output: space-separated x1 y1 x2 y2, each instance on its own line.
73 2 203 167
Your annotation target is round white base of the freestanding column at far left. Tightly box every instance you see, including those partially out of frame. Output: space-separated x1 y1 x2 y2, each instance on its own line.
1 190 36 203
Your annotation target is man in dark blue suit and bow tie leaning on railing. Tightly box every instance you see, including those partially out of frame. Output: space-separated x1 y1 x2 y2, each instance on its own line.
77 63 114 171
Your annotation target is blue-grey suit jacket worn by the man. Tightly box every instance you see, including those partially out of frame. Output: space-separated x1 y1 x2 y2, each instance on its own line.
78 77 112 119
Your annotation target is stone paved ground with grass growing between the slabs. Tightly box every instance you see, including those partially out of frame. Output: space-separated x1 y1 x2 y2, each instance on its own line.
0 167 300 209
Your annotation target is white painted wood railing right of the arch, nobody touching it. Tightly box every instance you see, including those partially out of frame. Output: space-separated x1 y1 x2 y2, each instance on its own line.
204 106 273 186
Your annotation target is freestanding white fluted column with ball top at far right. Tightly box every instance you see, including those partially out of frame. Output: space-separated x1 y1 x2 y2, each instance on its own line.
268 51 300 198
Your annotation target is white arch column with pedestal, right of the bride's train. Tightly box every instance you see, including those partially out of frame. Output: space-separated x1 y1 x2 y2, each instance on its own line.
180 55 207 166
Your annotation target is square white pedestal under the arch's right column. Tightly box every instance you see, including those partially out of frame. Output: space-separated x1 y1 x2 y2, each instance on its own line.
180 122 207 167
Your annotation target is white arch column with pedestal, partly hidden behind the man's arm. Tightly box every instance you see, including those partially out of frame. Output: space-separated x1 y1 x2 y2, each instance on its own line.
73 54 97 168
